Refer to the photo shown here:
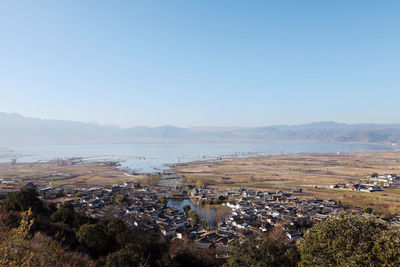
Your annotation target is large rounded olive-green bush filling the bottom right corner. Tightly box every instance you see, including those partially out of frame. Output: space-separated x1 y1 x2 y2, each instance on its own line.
299 215 400 266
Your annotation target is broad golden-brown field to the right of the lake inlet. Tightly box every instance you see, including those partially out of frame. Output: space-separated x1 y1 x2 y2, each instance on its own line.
173 152 400 214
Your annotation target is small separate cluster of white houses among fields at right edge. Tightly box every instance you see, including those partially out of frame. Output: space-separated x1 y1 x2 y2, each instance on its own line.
329 174 400 192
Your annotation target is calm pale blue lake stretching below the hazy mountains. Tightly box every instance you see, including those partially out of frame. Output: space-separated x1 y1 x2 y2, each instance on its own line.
0 142 393 172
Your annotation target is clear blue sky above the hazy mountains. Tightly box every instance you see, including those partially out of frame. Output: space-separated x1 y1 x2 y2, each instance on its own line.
0 0 400 126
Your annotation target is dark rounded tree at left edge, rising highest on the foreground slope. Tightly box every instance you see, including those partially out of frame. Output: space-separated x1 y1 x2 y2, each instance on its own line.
2 188 44 214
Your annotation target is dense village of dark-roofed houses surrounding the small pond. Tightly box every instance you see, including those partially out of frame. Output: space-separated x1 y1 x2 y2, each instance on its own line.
75 186 339 255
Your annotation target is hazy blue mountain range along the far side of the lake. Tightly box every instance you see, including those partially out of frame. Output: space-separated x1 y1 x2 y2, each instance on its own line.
0 113 400 146
